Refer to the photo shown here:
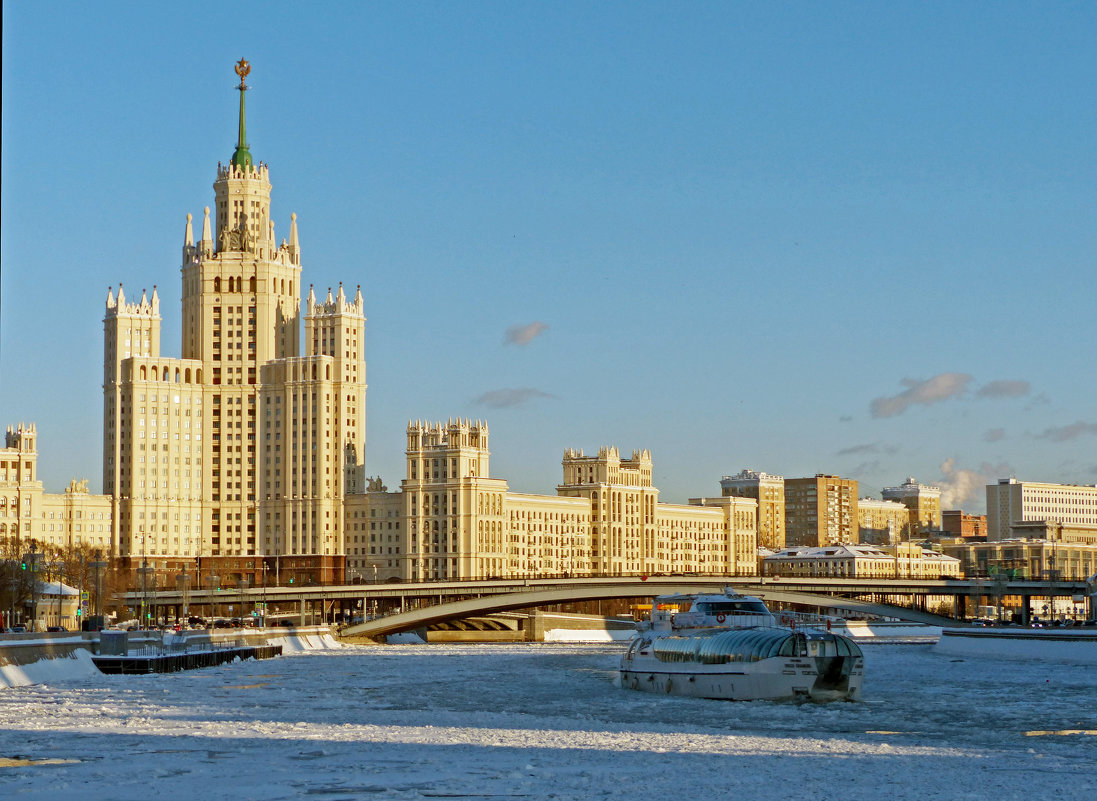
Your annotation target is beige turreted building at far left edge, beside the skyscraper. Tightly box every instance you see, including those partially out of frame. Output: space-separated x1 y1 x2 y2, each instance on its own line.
0 422 111 553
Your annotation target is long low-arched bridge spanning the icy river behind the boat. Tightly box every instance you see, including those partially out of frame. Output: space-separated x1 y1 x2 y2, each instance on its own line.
125 576 1092 636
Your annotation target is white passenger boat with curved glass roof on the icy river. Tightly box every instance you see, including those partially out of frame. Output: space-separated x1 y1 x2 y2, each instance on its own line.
621 590 864 701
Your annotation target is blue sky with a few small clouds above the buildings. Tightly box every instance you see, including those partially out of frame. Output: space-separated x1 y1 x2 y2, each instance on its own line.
0 2 1097 509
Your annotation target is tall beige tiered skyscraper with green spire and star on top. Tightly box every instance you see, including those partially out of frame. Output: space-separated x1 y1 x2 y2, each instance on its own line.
103 59 366 584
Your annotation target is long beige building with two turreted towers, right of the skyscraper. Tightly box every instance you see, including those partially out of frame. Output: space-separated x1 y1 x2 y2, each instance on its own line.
347 420 757 580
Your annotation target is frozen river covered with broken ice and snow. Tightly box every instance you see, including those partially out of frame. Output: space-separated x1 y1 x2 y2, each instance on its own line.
0 644 1097 801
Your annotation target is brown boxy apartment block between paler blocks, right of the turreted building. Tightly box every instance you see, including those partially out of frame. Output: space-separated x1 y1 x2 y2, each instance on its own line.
784 473 860 548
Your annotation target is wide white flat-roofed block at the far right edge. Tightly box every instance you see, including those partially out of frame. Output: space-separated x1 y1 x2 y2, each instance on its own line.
986 478 1097 541
